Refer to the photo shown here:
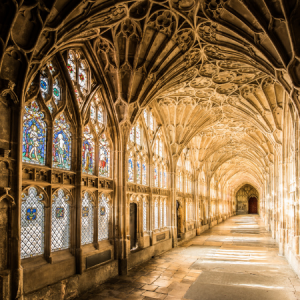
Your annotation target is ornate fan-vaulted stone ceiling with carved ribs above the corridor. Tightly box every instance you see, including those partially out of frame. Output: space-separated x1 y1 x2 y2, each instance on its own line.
0 0 300 190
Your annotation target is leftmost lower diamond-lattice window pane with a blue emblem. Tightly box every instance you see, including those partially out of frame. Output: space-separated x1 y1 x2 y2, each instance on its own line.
21 187 45 258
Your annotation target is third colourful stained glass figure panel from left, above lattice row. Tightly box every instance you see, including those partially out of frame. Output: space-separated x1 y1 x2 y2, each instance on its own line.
82 126 95 174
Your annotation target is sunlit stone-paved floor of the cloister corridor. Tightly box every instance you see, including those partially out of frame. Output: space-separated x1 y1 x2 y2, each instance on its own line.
78 215 300 300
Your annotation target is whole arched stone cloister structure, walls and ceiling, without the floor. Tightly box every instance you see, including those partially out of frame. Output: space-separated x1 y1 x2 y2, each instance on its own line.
0 0 300 299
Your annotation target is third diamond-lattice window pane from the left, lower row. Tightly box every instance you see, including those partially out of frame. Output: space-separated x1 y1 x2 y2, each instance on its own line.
81 192 94 245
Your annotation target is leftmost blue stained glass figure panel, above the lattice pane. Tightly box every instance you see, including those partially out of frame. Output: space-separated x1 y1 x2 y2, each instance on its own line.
22 101 46 165
